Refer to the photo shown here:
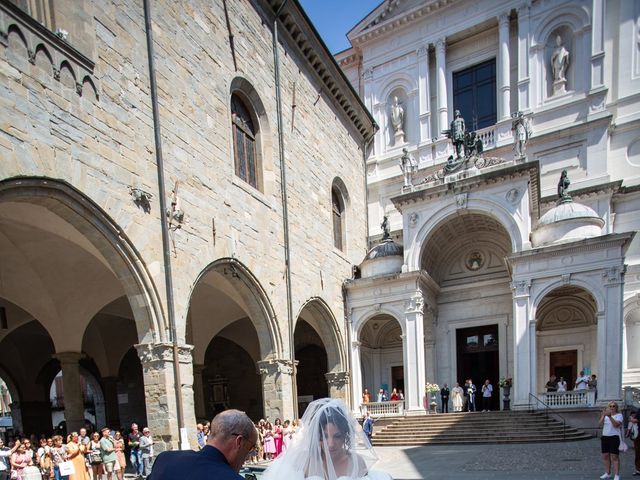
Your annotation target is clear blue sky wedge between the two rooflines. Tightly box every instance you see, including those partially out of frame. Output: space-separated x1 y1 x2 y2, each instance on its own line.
300 0 382 53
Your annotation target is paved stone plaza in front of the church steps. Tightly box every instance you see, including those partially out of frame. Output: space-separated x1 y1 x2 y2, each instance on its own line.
376 439 633 480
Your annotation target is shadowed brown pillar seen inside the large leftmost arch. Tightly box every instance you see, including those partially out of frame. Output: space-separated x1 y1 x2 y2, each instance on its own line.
53 352 84 433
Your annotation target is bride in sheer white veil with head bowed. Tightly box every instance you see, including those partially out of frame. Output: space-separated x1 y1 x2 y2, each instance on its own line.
262 398 391 480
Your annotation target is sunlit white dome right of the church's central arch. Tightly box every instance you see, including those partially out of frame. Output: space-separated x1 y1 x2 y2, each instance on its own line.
531 201 604 247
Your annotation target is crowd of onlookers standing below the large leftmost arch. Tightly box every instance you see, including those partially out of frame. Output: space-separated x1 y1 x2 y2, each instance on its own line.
0 423 154 480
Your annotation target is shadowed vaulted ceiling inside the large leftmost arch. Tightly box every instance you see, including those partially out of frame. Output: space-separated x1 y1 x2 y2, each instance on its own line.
0 207 124 352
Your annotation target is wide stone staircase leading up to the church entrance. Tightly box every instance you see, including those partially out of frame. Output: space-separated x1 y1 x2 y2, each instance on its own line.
372 411 591 446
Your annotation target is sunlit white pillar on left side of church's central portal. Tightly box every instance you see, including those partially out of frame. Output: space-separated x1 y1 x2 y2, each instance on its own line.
403 291 426 415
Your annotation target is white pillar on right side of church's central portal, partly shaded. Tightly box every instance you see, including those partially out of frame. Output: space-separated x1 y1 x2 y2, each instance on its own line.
511 280 536 409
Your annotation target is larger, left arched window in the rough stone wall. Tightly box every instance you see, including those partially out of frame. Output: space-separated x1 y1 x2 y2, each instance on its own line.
231 95 258 188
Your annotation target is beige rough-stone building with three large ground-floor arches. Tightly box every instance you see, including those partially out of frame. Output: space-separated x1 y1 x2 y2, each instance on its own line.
0 0 376 447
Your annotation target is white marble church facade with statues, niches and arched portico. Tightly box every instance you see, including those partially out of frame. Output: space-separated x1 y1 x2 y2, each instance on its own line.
337 0 640 413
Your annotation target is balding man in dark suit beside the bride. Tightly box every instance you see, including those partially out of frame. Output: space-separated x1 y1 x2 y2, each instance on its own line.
149 410 258 480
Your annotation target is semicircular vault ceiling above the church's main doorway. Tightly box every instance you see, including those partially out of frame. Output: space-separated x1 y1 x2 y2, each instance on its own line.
421 213 511 283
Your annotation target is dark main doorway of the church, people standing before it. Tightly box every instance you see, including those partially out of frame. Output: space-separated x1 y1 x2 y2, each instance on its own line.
456 325 500 410
